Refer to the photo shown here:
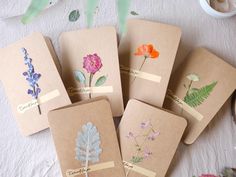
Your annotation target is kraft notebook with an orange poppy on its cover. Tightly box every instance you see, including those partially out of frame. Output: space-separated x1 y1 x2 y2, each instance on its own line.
119 19 181 107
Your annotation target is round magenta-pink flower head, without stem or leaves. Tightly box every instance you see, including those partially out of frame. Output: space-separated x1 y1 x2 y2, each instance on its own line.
83 53 102 74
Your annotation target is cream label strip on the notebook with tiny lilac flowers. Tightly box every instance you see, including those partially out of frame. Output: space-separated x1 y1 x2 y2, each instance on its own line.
123 161 156 177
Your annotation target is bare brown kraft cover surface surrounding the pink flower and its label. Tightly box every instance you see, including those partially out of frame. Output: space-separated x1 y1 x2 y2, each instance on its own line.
60 27 124 117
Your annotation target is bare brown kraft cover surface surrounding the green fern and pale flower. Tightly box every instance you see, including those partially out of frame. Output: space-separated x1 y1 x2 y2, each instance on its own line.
164 48 236 144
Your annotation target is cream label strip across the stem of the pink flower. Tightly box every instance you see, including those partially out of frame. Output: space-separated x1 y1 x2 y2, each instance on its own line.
67 86 113 96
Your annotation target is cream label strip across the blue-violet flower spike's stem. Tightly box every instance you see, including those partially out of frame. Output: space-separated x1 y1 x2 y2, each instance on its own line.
17 90 60 114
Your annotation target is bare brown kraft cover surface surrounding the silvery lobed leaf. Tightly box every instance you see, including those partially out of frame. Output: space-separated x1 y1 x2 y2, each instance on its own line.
48 98 124 177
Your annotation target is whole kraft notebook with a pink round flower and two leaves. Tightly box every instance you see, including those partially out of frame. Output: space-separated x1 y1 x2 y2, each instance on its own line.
60 27 124 117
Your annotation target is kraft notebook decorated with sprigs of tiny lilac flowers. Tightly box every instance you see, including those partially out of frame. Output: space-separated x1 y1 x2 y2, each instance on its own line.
119 100 187 177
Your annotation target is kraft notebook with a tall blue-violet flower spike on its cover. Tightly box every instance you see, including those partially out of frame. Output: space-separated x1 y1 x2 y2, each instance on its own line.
0 33 71 135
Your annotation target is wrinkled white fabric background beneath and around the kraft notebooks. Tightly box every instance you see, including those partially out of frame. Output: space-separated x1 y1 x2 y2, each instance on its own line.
0 0 236 177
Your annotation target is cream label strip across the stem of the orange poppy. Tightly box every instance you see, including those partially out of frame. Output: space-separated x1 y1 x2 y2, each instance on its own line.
120 65 161 83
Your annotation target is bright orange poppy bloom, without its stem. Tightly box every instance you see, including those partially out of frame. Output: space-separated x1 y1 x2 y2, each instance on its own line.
134 44 159 59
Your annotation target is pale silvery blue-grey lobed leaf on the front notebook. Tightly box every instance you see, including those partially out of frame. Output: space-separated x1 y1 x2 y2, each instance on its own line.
76 122 102 176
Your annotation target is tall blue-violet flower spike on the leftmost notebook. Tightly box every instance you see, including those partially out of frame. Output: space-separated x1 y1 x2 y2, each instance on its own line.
21 48 41 114
